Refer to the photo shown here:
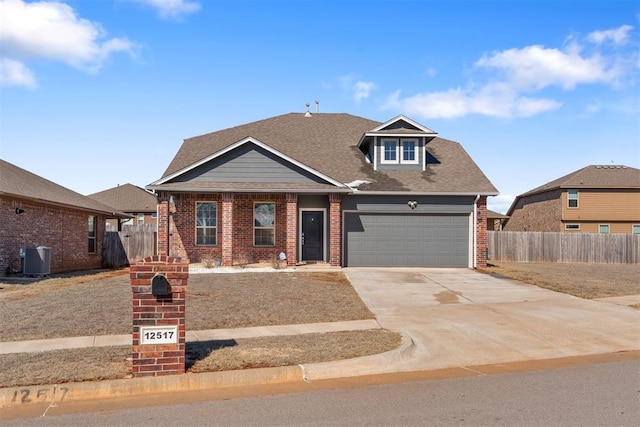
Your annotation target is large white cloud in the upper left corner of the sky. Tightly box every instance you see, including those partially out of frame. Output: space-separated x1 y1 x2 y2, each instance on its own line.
0 0 135 88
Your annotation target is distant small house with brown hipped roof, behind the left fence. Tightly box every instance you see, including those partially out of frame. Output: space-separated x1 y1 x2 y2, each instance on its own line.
88 184 158 231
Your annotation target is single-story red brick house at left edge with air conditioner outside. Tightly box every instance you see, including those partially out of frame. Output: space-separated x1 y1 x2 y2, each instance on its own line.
0 160 126 275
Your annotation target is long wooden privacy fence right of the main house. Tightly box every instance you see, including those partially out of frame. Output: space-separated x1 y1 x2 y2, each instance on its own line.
487 231 640 264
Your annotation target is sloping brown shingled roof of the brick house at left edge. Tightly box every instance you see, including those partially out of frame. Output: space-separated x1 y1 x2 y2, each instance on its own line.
0 159 128 218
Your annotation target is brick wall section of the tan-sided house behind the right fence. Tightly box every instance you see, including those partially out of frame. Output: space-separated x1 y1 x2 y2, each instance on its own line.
504 189 562 232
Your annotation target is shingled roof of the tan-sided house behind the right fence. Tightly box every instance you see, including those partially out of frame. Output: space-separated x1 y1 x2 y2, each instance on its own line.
520 165 640 197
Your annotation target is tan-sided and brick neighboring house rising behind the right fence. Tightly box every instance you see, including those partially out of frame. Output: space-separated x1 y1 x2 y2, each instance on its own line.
504 165 640 234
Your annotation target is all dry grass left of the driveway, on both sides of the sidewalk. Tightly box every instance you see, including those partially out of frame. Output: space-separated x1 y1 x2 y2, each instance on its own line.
0 270 400 387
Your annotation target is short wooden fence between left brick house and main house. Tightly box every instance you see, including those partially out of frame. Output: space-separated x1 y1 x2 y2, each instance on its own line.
102 224 157 268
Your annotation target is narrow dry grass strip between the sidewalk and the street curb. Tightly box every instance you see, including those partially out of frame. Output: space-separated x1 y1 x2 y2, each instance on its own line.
0 329 401 388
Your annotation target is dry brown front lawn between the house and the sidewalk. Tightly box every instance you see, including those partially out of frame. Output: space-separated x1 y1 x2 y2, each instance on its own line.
0 270 374 341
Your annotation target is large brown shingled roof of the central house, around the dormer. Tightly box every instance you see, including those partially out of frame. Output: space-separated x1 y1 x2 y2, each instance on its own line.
152 113 498 195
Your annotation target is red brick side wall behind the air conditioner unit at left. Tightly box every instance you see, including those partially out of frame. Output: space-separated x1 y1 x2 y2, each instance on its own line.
0 197 106 275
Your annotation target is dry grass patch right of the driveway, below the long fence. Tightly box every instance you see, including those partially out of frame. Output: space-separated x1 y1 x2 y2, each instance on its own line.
482 261 640 299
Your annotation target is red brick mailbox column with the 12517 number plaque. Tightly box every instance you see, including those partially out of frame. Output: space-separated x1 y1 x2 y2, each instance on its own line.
130 255 189 377
